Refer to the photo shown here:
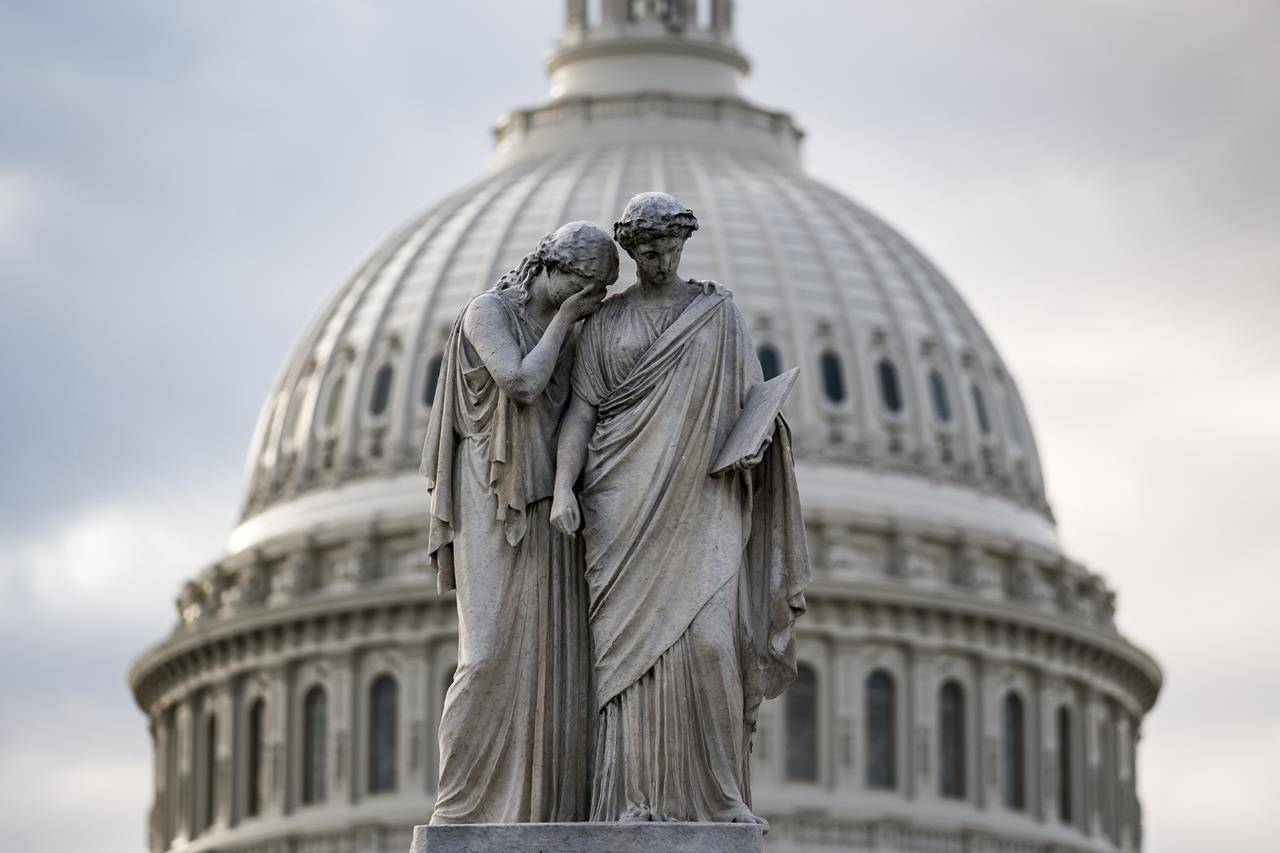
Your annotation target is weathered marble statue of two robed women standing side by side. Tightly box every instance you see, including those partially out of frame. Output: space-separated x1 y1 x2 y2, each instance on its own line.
422 192 809 839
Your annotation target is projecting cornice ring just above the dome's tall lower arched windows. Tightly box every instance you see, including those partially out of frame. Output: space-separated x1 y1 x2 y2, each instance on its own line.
131 563 1161 717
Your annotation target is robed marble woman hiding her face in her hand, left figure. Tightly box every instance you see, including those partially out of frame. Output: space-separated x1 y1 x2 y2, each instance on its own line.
422 222 618 824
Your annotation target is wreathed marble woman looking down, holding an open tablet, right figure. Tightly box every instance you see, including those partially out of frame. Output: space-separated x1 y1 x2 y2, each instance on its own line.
552 192 809 824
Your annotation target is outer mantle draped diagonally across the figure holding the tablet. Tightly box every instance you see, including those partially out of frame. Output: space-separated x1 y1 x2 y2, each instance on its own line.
573 287 809 721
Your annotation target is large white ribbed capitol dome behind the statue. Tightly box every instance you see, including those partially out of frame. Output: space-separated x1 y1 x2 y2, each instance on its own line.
131 0 1161 853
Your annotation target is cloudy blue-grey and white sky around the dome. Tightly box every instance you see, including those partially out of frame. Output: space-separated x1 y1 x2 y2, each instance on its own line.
0 0 1280 853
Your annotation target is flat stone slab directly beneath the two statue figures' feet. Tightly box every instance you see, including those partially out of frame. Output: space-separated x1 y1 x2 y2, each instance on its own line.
411 824 764 853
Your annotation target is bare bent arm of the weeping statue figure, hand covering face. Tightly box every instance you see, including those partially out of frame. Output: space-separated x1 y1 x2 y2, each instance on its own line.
462 287 604 403
